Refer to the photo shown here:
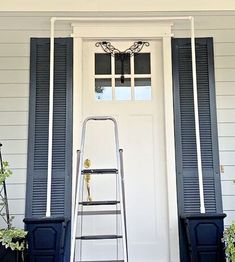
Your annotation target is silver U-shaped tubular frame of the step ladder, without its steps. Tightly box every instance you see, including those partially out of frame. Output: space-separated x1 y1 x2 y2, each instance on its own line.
70 116 128 262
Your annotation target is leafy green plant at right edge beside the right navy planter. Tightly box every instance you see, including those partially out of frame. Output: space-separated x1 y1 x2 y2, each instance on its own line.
222 223 235 262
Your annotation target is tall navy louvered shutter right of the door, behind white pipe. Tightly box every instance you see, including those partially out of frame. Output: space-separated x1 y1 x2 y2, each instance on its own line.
172 38 222 214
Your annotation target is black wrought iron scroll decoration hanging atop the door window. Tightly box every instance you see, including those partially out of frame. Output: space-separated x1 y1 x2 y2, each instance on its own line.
95 41 150 84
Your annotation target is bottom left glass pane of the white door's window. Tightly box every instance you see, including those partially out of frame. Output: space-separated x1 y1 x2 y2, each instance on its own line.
95 78 112 100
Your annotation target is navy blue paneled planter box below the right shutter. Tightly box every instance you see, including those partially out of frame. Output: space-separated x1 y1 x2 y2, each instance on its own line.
181 214 226 262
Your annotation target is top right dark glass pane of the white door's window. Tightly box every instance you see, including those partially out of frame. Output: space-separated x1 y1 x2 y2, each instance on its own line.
134 53 151 74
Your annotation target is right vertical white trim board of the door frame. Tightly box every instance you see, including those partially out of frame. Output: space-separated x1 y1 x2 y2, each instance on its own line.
163 37 180 262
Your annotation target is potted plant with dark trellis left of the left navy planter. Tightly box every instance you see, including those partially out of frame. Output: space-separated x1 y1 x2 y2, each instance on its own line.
0 144 27 262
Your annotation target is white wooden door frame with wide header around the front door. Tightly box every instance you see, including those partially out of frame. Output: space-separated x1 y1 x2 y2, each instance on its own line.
72 18 180 262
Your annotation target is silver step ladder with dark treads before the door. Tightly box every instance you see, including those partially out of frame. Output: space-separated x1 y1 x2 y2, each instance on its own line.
70 116 128 262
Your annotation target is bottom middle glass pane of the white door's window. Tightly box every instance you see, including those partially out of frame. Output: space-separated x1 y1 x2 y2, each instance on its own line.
115 78 131 100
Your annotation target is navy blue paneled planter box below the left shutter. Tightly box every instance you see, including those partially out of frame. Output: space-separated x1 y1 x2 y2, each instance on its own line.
24 217 68 262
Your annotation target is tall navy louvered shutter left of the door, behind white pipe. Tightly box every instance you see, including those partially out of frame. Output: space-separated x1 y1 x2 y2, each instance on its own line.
26 38 73 217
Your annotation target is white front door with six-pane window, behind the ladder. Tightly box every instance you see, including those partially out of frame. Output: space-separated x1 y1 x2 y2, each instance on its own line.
78 40 169 262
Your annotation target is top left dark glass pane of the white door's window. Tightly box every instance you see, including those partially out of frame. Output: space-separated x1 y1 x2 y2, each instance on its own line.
95 54 111 75
